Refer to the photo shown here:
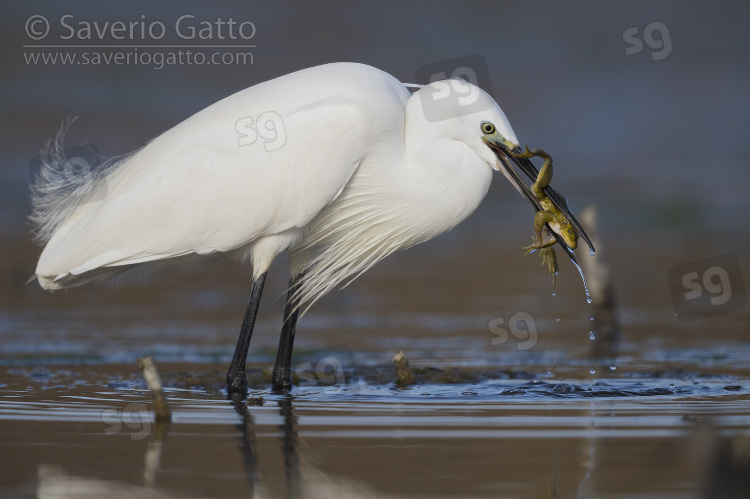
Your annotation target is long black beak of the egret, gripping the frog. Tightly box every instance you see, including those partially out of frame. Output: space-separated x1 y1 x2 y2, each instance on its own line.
489 143 595 265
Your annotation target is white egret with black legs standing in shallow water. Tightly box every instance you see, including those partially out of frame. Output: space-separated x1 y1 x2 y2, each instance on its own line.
31 63 587 393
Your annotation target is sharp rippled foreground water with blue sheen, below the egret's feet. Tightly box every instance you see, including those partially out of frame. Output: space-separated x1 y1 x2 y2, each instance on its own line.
0 365 750 497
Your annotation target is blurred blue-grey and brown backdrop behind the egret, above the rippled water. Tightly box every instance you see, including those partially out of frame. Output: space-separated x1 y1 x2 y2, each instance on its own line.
0 1 750 372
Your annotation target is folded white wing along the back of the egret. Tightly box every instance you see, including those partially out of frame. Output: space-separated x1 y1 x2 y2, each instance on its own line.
37 64 408 287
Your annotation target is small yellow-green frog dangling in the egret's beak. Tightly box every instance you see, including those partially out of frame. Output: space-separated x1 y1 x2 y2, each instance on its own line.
510 146 578 285
